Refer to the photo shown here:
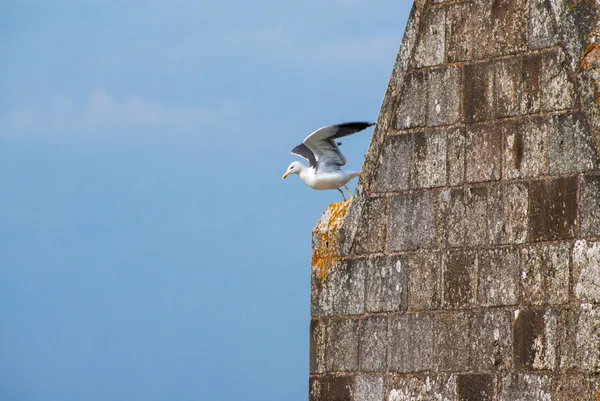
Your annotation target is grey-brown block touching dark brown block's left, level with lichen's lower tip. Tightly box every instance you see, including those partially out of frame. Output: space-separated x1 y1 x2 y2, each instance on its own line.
408 251 441 311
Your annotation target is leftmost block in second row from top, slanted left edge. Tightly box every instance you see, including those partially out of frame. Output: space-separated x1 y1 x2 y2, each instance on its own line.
395 71 429 130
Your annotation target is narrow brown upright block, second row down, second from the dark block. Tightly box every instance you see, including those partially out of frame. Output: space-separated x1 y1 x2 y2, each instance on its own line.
520 53 542 114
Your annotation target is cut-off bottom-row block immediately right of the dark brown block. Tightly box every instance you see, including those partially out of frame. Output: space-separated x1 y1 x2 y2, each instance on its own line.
500 373 552 401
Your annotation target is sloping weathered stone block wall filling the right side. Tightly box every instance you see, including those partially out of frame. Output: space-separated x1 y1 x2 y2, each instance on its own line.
310 0 600 401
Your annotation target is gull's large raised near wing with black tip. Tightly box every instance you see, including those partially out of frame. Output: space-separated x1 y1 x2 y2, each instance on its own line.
296 122 375 171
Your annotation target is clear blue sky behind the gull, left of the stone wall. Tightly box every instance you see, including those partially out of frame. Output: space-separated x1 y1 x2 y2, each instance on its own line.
0 0 411 401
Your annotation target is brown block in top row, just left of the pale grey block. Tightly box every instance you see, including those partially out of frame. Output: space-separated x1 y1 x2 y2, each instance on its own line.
488 0 529 55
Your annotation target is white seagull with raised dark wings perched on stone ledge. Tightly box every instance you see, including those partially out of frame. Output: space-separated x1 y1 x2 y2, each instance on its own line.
281 122 375 201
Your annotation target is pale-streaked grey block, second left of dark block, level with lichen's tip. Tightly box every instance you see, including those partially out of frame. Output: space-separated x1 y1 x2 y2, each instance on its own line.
365 256 408 312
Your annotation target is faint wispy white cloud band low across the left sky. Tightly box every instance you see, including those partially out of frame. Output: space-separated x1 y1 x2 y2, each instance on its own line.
0 89 239 141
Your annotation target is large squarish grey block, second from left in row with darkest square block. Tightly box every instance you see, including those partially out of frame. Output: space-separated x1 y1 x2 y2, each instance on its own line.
387 192 437 252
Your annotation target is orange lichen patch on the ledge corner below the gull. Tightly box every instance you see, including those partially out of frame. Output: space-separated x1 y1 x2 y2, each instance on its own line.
312 201 351 280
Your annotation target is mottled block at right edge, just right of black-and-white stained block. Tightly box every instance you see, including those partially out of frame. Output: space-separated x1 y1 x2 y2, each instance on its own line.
559 304 600 373
